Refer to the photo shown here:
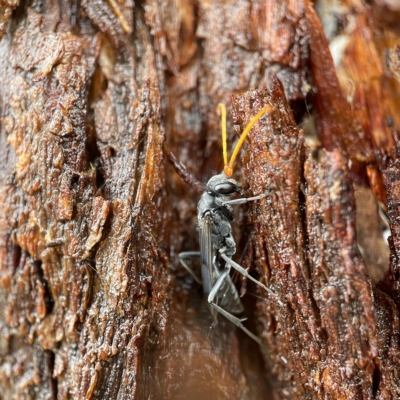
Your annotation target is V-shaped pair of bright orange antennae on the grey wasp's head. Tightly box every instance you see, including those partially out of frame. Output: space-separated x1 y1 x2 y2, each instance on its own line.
217 103 272 178
